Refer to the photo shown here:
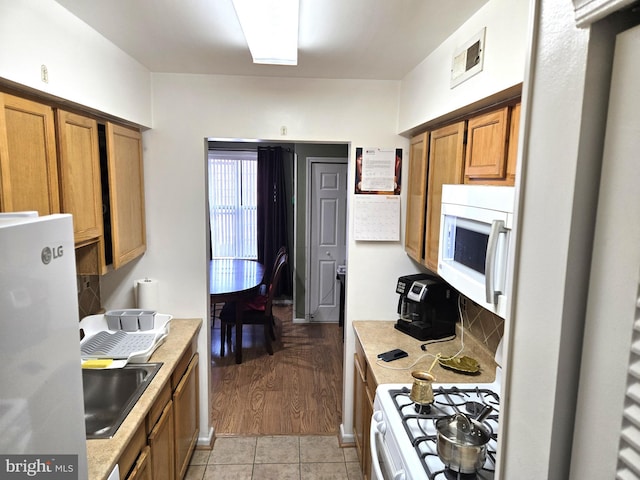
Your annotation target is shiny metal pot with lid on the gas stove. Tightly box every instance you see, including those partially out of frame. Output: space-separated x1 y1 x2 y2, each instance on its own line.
435 405 493 473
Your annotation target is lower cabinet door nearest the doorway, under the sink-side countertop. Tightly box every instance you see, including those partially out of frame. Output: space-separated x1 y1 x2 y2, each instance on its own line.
173 353 199 480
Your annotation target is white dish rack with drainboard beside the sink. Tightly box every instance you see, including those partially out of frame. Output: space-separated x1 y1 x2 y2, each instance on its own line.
80 310 173 368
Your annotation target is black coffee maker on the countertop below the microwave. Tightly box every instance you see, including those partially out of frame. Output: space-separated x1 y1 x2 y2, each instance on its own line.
395 273 458 341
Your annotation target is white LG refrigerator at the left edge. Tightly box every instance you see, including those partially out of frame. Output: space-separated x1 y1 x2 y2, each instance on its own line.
0 213 87 478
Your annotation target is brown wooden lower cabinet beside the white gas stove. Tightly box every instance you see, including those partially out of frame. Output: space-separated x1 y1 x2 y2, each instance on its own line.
353 339 377 480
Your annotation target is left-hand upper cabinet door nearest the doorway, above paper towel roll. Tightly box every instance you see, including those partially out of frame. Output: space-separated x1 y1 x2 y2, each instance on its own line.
106 123 146 269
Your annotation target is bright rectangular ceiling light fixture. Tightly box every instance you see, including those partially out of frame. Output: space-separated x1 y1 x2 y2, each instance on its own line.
232 0 300 65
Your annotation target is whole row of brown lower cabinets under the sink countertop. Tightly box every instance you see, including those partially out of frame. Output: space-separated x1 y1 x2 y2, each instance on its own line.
118 339 199 480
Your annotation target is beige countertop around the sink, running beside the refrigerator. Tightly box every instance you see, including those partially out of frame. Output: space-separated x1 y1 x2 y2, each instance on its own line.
87 319 202 480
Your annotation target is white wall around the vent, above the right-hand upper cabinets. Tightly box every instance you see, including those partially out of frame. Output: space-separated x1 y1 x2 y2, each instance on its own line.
399 0 529 132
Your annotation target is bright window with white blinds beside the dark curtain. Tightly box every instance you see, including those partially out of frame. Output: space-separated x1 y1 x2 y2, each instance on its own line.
209 151 258 259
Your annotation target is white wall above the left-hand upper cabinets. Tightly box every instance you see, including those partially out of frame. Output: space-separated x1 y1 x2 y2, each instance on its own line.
0 0 151 126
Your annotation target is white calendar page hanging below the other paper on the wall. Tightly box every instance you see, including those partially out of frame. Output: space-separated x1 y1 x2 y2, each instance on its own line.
354 195 400 242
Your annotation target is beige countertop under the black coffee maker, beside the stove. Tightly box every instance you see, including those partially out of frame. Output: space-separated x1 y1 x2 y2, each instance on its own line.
353 320 497 385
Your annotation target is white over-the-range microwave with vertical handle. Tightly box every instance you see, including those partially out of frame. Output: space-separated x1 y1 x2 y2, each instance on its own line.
438 185 515 318
